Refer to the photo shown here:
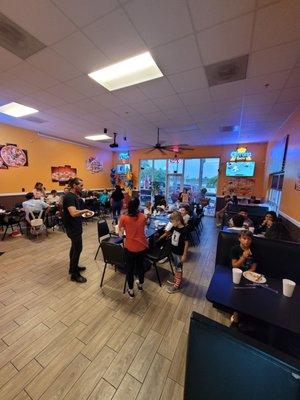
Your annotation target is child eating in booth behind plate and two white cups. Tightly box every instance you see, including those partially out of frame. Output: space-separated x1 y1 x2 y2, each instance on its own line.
230 230 257 325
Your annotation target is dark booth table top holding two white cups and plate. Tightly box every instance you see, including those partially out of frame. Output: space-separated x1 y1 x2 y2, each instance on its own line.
206 265 300 335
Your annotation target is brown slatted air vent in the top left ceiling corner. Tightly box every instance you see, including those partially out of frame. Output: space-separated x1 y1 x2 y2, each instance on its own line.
0 13 46 60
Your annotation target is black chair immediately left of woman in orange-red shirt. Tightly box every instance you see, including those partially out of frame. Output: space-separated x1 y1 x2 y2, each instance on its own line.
100 240 126 293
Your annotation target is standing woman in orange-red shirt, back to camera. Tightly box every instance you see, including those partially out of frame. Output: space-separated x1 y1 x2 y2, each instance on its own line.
119 198 148 297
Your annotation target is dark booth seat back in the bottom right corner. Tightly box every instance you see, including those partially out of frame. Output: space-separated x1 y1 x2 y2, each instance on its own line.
184 312 300 400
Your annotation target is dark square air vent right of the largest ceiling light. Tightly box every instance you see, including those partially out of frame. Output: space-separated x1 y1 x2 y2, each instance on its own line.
204 55 249 86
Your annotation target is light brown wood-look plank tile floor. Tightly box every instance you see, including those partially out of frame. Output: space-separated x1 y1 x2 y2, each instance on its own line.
0 217 228 400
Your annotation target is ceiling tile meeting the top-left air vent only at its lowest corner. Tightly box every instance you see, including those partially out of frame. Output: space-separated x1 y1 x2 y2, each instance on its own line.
10 61 58 89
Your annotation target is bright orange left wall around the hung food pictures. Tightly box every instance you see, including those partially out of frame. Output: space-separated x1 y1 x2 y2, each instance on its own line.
0 125 112 193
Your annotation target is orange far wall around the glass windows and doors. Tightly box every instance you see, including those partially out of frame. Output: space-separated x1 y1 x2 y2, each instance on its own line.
113 143 267 197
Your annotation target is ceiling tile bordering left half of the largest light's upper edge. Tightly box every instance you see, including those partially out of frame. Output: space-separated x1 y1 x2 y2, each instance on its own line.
52 32 108 74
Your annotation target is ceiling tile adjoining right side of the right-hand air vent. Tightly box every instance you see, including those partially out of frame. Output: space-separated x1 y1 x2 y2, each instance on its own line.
247 41 300 77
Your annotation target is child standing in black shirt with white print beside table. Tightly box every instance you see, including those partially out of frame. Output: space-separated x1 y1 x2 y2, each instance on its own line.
167 211 189 293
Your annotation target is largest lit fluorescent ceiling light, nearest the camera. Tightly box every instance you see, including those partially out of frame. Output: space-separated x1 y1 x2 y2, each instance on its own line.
89 51 163 91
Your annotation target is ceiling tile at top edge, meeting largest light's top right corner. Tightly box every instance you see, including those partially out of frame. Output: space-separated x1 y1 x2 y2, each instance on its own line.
125 0 192 47
